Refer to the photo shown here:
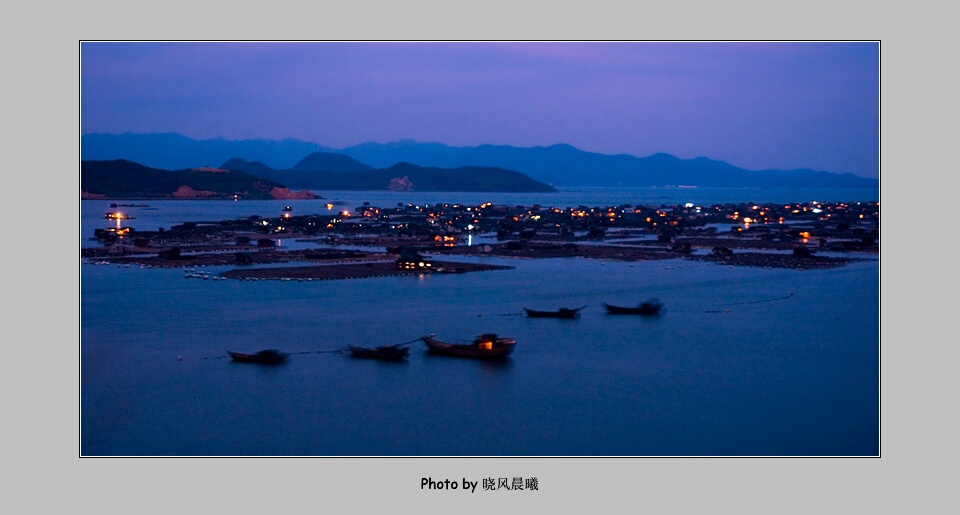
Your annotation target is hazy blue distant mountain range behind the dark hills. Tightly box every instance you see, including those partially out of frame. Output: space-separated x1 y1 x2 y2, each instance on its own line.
81 133 879 191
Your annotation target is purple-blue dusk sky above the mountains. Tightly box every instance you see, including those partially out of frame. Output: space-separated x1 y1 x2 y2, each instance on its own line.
80 42 880 177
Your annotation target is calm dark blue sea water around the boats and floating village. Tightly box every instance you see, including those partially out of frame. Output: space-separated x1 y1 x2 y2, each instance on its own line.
79 190 880 456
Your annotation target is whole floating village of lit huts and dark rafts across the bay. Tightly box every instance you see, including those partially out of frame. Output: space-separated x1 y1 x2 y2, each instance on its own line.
81 200 880 281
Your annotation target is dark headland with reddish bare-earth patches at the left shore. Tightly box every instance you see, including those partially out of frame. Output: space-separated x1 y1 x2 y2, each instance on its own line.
80 159 313 199
